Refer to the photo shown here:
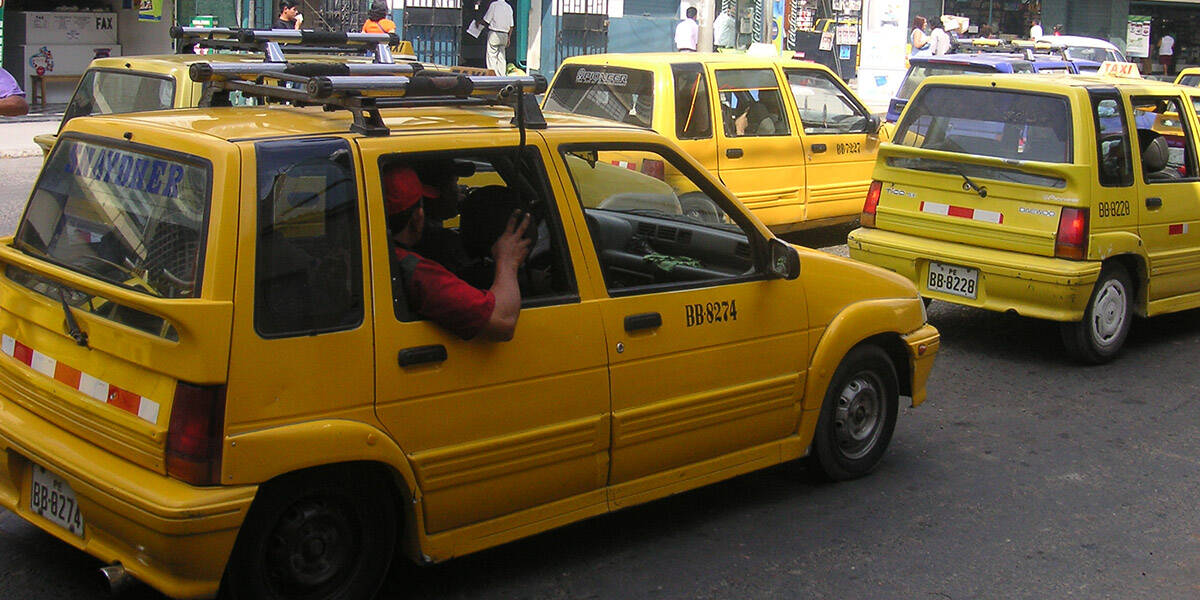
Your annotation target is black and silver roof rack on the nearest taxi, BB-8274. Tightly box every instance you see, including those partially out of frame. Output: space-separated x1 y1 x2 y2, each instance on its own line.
188 60 547 136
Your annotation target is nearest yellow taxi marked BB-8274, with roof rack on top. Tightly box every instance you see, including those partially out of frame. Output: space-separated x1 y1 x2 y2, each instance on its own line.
0 65 938 600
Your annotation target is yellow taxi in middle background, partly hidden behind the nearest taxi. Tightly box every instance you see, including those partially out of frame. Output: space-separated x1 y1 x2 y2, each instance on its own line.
542 53 880 233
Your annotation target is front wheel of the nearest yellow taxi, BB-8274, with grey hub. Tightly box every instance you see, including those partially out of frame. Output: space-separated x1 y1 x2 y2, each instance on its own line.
805 346 900 481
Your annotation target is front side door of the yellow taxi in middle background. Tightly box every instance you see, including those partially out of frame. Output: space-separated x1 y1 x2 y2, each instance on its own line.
784 68 880 221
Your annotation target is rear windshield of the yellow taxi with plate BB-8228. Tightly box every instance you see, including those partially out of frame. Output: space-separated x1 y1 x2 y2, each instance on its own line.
893 85 1072 163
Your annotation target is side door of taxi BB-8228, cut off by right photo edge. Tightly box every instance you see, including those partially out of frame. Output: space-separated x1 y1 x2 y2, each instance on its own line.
1128 92 1200 301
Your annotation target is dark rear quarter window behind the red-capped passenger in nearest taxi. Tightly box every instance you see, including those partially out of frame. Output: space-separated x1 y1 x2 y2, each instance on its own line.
254 139 362 337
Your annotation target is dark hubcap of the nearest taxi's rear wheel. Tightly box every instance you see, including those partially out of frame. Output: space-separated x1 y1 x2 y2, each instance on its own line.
266 499 358 595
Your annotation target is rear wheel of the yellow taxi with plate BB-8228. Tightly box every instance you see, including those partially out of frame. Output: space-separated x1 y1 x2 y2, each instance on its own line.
1061 263 1134 365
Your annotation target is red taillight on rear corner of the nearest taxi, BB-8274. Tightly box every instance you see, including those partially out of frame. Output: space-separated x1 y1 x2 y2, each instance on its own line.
167 382 224 485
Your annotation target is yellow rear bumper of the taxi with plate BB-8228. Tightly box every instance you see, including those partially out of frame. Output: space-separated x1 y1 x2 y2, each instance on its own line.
846 228 1100 322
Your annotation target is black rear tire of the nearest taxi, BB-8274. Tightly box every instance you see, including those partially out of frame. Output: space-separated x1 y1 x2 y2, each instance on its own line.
222 466 397 600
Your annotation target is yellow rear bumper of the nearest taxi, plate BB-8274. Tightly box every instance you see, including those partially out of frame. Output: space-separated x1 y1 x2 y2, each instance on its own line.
0 382 257 598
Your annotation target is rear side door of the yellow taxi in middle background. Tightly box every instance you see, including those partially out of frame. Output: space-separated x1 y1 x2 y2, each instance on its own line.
710 65 808 230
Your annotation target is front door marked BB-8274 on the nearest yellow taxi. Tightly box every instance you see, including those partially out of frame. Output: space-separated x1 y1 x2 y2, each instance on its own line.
556 143 809 506
